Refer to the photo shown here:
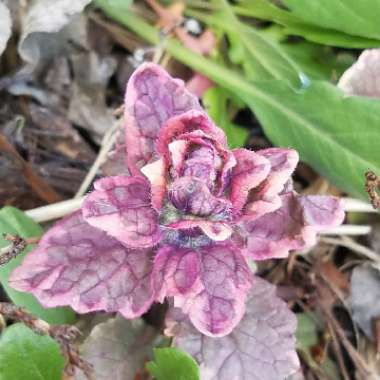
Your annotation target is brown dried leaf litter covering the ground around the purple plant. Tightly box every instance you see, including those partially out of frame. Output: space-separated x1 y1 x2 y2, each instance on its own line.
0 0 380 380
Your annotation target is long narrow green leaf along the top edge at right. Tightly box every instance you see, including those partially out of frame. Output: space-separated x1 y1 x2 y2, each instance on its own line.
234 0 379 48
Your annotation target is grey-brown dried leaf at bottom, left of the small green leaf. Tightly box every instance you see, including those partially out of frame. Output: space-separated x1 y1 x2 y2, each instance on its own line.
76 316 157 380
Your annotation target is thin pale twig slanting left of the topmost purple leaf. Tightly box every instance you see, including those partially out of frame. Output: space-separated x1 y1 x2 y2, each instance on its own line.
74 118 123 199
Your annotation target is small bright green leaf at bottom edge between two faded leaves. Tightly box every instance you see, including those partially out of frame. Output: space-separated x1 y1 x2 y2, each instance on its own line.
147 348 199 380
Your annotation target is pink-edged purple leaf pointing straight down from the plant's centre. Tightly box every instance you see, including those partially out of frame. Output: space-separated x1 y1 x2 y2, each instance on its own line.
153 243 251 337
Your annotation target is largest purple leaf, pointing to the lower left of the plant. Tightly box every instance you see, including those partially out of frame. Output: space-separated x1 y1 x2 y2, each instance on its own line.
10 212 154 318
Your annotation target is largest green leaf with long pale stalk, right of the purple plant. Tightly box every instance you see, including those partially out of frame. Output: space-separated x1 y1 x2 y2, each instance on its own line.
95 2 380 199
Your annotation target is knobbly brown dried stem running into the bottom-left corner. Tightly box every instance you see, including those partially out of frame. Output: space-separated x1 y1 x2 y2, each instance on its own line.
0 302 93 380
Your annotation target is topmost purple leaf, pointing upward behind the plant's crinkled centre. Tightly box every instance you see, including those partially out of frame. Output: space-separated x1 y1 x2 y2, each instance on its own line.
125 64 201 175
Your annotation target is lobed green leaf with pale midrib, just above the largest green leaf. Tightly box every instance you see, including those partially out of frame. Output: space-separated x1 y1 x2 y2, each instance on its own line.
193 5 354 86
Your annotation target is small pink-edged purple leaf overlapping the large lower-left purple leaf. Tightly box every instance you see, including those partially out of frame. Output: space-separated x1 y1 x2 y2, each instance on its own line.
82 176 160 248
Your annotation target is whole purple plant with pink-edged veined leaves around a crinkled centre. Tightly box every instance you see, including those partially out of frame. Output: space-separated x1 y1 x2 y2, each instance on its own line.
11 64 344 378
